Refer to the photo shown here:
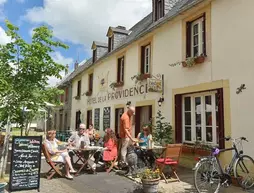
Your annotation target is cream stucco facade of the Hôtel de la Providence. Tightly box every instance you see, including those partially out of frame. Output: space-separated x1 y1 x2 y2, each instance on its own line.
71 0 254 166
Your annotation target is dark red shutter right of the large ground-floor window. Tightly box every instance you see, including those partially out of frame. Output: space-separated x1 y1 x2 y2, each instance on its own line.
217 88 225 149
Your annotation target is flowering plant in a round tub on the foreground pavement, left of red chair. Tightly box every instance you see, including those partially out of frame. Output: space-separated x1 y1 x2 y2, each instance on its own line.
139 169 160 193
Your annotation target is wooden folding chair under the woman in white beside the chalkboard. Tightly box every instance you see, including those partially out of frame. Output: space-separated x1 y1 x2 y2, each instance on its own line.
42 144 64 180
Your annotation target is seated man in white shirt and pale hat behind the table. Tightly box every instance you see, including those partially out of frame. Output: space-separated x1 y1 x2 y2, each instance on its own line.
68 123 96 170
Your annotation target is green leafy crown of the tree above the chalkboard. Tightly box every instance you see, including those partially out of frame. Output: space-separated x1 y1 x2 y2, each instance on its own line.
0 20 68 134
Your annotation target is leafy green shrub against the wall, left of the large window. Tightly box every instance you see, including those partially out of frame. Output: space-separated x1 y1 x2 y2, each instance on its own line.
153 110 172 144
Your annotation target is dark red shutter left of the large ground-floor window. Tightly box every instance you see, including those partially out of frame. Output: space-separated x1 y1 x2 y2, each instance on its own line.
175 95 183 143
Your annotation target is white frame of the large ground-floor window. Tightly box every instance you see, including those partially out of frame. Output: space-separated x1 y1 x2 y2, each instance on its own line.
182 91 218 145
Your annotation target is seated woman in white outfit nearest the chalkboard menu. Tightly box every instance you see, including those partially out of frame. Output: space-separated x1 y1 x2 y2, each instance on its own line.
45 130 76 179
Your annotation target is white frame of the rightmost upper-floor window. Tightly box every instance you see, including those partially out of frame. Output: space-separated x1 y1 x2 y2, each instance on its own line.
191 17 204 57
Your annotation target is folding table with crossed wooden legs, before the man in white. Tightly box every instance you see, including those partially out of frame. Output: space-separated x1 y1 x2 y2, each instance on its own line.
67 146 103 176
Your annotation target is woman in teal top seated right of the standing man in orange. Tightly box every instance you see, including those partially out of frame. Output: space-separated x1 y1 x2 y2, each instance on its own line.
136 124 155 167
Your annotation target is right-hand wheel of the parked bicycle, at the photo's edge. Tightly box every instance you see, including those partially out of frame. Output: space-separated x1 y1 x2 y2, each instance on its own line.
234 155 254 189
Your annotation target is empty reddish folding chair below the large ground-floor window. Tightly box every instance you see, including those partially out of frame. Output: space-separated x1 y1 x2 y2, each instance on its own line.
156 144 182 183
